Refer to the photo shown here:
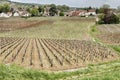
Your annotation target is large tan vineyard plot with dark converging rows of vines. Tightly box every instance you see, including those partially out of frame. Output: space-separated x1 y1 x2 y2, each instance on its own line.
0 37 119 70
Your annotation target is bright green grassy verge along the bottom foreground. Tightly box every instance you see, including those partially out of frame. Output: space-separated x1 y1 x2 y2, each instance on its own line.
0 60 120 80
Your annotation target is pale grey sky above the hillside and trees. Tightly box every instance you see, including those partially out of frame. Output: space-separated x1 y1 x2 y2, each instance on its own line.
11 0 120 8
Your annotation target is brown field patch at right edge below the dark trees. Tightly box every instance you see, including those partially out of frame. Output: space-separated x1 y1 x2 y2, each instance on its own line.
97 24 120 45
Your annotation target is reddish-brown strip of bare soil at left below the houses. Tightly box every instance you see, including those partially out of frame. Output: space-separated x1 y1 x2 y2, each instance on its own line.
0 20 53 32
